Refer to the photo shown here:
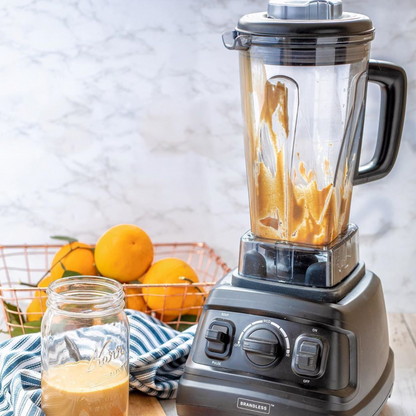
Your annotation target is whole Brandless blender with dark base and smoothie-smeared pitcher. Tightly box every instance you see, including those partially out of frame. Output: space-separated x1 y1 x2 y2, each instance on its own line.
177 0 406 416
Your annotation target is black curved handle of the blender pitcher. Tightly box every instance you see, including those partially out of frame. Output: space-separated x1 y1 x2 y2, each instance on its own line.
354 60 407 185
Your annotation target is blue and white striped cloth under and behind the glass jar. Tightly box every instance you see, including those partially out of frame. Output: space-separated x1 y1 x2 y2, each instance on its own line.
0 310 196 416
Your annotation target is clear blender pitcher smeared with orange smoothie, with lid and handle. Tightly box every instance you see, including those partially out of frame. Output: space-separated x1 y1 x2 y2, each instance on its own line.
223 0 406 247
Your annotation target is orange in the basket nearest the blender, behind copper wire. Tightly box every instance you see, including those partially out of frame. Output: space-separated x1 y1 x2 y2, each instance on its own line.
142 258 202 321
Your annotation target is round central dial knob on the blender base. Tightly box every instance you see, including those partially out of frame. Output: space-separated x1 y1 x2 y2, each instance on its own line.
242 329 280 366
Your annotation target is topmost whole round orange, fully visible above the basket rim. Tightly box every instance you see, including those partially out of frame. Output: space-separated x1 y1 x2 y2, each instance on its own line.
95 224 153 283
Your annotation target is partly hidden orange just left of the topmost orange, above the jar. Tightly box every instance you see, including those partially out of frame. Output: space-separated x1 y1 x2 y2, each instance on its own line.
49 242 98 283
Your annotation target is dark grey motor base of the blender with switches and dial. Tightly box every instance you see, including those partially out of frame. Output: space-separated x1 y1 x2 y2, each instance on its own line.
177 264 394 416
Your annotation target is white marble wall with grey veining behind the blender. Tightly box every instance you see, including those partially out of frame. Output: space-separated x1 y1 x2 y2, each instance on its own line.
0 0 416 312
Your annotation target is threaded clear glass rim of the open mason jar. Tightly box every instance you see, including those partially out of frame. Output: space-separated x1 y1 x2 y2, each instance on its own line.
46 276 124 316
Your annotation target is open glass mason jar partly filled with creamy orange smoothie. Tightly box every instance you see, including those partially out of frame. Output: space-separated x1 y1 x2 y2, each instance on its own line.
42 276 129 416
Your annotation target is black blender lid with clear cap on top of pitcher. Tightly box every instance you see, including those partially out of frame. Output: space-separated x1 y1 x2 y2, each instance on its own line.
236 0 374 37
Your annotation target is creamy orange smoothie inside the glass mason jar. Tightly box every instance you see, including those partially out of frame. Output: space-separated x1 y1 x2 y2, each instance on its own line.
42 361 129 416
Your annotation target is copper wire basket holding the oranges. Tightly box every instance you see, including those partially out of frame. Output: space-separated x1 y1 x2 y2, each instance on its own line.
0 243 230 336
